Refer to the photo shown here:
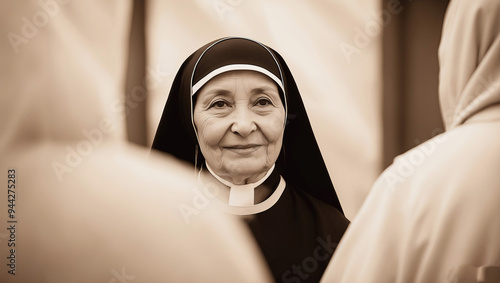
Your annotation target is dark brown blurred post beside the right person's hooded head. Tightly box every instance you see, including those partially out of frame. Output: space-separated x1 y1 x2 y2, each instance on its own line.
382 0 449 167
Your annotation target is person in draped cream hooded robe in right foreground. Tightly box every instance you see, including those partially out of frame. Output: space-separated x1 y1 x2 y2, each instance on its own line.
322 0 500 283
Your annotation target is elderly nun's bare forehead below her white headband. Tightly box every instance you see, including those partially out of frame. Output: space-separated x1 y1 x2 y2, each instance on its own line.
200 71 278 94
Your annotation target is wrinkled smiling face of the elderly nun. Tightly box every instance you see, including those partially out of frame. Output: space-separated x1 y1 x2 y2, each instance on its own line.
194 71 285 184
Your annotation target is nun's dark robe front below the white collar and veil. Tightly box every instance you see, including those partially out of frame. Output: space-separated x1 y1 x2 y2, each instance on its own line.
247 169 349 282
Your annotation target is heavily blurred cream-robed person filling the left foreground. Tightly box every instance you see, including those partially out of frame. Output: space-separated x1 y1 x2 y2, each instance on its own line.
0 0 270 283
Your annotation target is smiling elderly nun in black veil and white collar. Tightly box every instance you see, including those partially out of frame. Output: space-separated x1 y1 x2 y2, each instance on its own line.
153 37 349 282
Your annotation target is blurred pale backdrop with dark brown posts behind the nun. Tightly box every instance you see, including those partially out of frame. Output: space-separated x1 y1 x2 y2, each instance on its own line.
0 0 448 219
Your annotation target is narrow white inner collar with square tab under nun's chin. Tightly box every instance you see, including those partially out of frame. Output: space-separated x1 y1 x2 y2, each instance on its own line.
205 163 275 206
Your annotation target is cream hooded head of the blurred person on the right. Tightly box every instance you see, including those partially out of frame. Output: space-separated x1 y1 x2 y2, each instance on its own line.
439 0 500 129
